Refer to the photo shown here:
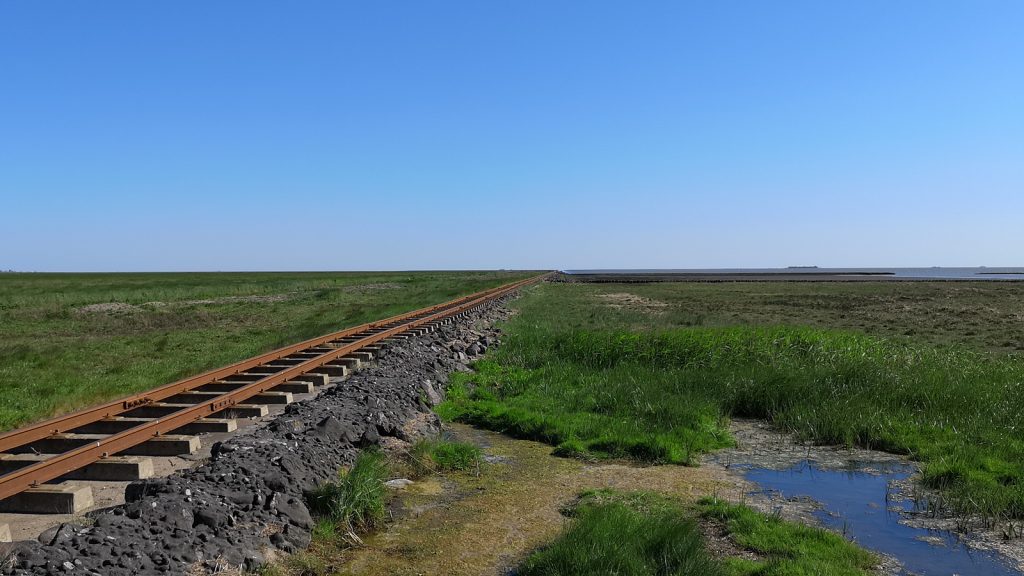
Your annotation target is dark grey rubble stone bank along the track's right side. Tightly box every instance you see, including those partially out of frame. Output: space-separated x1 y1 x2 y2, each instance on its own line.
2 295 507 576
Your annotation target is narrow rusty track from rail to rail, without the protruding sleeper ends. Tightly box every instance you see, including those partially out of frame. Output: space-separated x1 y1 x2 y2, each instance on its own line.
0 275 547 500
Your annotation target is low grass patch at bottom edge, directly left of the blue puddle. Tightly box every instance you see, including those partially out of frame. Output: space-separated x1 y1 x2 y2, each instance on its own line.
699 498 878 576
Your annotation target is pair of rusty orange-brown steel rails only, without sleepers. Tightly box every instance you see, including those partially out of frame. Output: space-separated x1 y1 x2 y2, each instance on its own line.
0 275 547 499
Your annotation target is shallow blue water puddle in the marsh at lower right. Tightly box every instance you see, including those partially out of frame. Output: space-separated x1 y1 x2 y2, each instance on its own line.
736 459 1024 576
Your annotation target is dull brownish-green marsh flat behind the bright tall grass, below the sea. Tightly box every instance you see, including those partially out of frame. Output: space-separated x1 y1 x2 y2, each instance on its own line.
552 282 1024 353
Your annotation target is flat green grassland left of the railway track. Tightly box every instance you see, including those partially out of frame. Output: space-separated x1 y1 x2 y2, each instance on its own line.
0 272 528 429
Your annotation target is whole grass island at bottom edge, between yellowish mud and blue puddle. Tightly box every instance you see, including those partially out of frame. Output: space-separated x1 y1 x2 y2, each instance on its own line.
518 490 877 576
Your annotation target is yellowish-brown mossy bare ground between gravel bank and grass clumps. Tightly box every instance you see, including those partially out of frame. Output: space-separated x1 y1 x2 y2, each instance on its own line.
340 424 744 576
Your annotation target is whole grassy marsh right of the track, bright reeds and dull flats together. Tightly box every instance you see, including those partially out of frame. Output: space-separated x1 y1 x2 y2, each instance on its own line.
439 283 1024 520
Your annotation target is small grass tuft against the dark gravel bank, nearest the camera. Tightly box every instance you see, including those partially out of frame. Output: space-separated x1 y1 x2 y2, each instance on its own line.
309 450 388 538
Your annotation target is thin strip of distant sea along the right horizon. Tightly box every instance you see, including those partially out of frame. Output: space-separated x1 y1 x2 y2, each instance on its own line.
562 266 1024 280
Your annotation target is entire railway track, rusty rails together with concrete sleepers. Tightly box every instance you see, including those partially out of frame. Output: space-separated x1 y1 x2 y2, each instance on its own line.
0 275 546 513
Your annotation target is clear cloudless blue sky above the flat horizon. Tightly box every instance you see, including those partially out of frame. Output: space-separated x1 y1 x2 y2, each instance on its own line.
0 0 1024 271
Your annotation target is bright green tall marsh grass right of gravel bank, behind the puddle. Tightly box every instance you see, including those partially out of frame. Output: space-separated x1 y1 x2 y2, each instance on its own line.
438 285 1024 523
